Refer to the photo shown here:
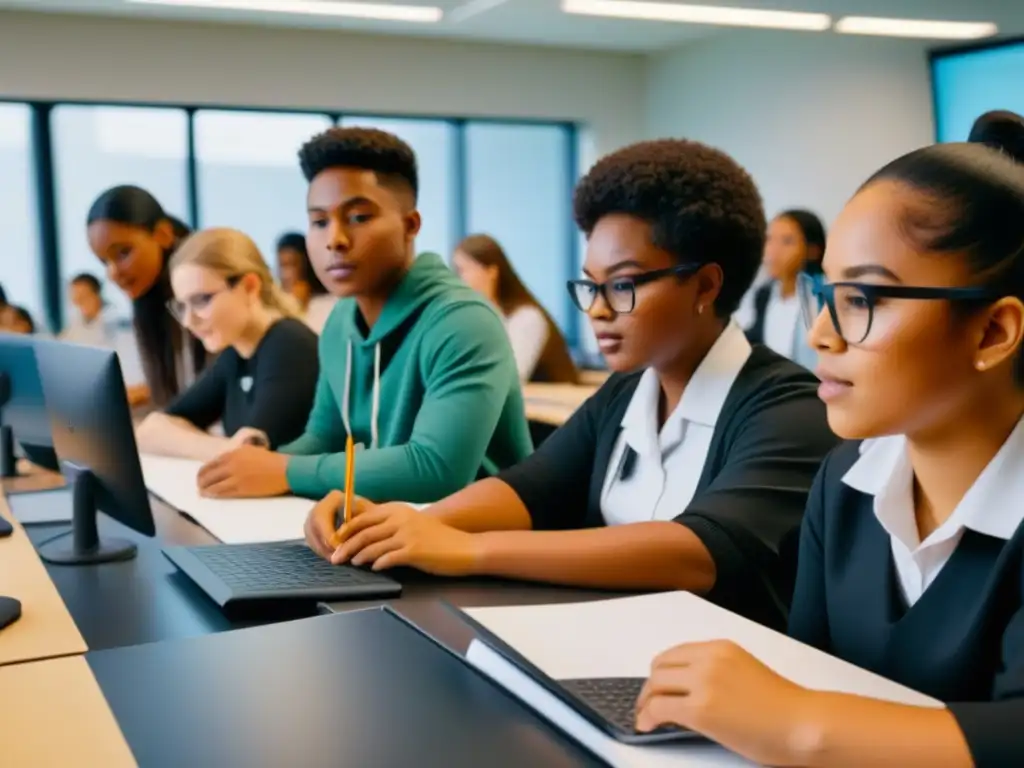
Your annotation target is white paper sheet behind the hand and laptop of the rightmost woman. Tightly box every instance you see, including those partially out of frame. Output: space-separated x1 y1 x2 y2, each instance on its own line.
466 592 943 707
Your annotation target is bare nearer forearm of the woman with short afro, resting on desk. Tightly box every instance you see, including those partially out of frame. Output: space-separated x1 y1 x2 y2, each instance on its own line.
468 522 715 593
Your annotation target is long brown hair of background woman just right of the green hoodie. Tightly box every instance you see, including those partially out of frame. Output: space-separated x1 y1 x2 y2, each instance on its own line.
456 234 578 384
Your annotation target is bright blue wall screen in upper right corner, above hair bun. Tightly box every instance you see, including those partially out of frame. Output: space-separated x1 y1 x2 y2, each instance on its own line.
932 43 1024 141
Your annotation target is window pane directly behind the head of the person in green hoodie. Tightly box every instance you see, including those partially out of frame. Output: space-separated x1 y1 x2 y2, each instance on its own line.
341 117 458 261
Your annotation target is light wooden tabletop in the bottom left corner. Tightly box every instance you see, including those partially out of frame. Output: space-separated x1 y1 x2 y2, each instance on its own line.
0 655 137 768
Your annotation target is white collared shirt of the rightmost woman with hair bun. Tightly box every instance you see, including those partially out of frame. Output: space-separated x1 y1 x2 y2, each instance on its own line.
843 419 1024 607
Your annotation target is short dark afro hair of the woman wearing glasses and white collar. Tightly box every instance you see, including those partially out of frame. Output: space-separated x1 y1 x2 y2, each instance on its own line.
573 139 768 317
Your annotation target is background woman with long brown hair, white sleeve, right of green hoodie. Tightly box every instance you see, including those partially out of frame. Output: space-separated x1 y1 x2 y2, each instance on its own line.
452 234 577 384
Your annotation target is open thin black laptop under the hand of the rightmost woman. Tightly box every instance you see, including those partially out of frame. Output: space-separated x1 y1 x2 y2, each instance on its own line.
384 601 706 745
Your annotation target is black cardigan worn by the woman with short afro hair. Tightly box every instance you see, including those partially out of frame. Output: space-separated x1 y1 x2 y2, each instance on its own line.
500 345 837 628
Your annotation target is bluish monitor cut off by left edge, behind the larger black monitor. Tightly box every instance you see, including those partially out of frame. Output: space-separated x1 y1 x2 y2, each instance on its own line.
0 333 60 477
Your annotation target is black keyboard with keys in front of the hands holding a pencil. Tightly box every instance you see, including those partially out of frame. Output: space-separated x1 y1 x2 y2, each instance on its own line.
189 542 390 592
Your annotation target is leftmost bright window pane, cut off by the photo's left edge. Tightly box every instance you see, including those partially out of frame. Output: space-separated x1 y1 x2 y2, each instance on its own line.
0 103 46 329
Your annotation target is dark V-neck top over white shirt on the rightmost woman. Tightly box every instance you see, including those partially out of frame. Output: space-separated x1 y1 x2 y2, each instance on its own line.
790 442 1024 768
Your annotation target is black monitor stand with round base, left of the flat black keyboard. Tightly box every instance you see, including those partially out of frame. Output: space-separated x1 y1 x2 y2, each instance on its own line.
39 463 136 565
